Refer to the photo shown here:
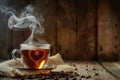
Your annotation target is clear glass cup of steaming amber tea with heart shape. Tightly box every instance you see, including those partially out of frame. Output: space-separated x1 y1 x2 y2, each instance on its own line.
12 44 50 69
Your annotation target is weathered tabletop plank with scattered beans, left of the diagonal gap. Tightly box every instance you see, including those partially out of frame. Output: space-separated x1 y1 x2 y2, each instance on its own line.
67 62 116 80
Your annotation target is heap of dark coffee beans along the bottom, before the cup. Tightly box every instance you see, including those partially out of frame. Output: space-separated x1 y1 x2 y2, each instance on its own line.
18 71 80 80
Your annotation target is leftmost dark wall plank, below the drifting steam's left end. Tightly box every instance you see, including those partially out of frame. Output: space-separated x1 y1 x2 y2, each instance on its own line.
0 12 12 59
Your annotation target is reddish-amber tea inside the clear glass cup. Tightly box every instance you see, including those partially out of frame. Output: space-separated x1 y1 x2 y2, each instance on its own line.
22 49 49 69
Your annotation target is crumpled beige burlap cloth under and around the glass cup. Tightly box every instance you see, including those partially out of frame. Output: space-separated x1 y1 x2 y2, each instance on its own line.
0 54 74 77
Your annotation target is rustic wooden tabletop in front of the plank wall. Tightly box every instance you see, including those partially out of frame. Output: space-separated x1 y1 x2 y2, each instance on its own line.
0 62 120 80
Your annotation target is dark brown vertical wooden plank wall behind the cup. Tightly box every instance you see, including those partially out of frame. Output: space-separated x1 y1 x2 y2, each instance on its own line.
0 0 120 61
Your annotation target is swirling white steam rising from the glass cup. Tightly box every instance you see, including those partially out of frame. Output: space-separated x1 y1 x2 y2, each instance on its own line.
0 5 46 44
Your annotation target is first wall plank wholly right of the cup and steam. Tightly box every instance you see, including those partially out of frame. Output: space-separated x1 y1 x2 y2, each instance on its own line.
57 0 79 60
